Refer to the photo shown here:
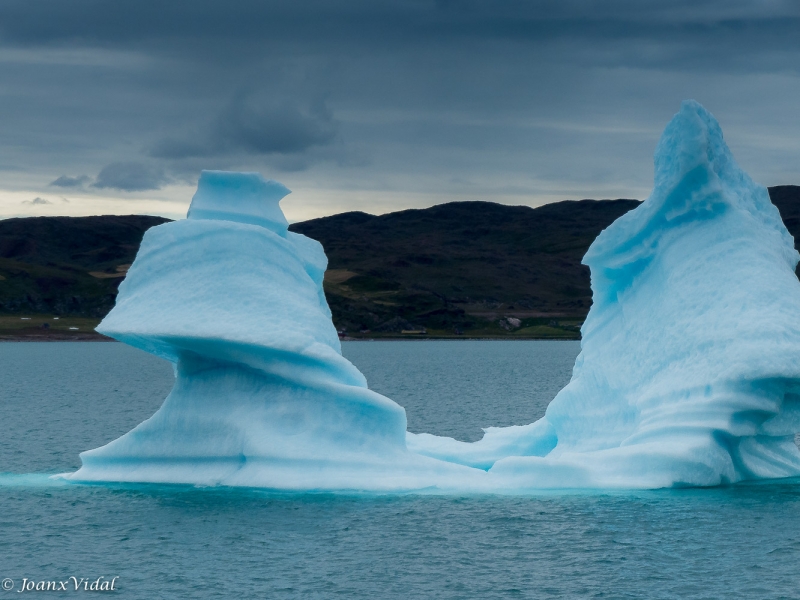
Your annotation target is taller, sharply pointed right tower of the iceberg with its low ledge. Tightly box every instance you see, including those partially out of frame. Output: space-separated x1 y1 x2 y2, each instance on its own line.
408 101 800 488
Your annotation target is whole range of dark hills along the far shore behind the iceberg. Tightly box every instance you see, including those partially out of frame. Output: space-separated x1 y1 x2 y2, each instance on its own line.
0 186 800 339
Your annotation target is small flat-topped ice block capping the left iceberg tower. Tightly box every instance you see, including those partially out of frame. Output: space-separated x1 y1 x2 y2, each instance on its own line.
186 171 291 237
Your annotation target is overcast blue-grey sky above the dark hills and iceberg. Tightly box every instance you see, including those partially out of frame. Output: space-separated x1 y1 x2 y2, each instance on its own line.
0 0 800 221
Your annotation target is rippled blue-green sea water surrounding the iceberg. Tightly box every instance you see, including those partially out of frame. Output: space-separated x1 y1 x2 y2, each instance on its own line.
0 341 800 599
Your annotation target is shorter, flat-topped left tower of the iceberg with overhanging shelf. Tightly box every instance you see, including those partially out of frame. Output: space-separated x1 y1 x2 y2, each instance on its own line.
69 171 476 490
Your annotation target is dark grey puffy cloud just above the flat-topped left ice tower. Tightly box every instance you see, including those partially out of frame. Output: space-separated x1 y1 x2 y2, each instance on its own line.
150 95 338 159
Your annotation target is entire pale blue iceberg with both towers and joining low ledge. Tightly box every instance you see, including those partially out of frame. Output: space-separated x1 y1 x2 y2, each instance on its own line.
70 101 800 493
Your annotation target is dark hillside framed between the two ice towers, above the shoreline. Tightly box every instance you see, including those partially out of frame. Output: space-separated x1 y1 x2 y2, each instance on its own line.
291 200 639 331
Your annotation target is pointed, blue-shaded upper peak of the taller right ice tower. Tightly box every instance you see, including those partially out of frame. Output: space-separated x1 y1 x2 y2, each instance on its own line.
583 100 798 305
